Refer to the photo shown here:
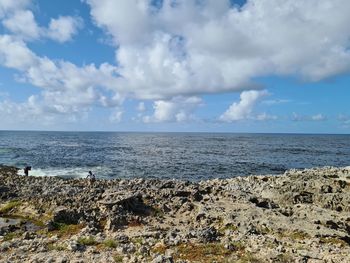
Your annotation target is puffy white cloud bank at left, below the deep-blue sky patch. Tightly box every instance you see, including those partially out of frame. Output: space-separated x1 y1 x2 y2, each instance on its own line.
0 35 124 121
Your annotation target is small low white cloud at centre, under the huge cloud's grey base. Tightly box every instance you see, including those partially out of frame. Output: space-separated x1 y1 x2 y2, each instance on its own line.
143 97 203 123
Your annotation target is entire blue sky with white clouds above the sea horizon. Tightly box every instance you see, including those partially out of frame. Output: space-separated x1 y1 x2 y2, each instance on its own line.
0 0 350 134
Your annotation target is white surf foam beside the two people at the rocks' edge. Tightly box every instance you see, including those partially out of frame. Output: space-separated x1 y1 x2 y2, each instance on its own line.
18 166 112 178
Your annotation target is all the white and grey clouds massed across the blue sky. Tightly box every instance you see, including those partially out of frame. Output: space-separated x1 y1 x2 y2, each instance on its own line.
0 0 350 126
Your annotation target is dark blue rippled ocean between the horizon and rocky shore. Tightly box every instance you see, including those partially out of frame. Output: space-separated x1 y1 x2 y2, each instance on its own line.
0 131 350 181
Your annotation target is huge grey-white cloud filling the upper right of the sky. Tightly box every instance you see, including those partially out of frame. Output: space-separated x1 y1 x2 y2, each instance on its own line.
86 0 350 100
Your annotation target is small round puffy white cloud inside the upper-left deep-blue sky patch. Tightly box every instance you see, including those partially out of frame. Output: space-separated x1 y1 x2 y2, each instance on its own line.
46 16 82 43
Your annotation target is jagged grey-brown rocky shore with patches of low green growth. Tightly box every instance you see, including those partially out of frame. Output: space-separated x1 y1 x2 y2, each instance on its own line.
0 166 350 263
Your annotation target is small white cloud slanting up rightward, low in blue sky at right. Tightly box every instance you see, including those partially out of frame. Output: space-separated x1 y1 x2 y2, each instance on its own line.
219 90 268 122
